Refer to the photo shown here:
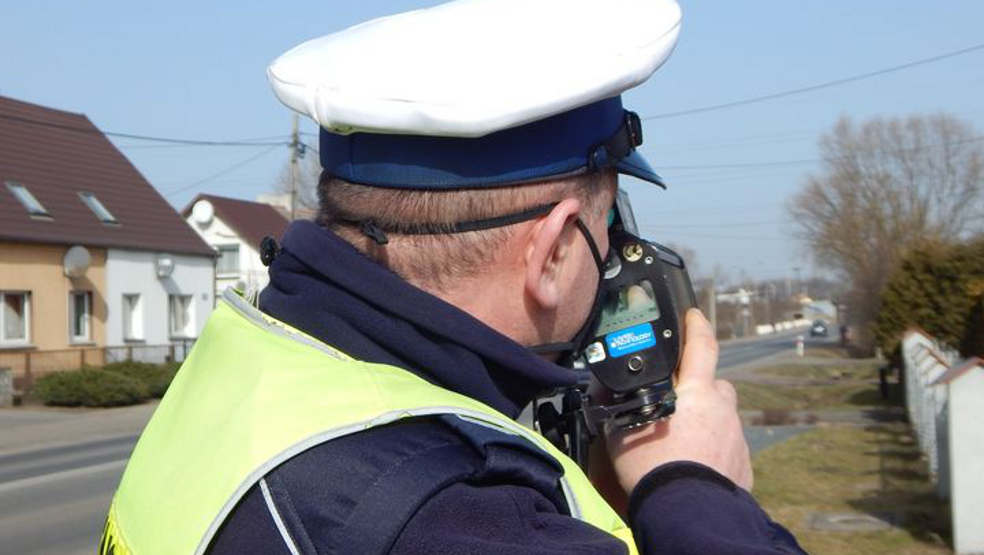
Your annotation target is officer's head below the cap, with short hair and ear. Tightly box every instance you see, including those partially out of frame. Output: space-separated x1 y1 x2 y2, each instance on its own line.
318 171 616 350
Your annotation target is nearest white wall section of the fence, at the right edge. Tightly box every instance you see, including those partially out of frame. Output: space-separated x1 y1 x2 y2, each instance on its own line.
948 366 984 553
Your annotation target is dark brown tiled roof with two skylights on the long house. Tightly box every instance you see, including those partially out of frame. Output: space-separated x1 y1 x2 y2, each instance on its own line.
0 96 215 256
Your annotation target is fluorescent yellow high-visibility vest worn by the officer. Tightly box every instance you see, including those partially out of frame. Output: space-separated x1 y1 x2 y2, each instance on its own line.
100 292 636 555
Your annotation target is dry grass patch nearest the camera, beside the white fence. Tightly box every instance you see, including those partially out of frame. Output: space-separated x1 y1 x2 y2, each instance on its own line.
753 423 950 554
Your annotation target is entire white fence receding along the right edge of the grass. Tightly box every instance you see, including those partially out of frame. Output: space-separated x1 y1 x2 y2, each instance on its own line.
902 331 984 553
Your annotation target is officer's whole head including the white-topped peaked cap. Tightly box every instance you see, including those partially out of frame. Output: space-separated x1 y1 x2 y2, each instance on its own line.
267 0 681 352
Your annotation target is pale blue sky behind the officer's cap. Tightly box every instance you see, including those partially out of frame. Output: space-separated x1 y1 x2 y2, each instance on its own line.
0 0 984 278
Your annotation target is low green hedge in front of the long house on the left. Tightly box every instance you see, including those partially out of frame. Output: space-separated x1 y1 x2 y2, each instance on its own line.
33 361 180 407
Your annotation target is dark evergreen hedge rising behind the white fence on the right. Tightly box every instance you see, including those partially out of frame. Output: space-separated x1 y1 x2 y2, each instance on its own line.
874 237 984 356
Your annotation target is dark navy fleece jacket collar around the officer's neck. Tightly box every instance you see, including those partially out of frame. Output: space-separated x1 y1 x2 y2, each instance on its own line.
260 221 576 418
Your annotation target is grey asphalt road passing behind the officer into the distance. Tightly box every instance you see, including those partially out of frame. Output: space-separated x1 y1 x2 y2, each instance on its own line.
0 333 820 555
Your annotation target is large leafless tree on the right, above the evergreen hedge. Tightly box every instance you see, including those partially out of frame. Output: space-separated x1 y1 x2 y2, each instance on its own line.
788 114 984 348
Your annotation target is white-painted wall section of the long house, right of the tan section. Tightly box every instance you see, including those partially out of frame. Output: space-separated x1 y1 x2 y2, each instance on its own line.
106 249 214 346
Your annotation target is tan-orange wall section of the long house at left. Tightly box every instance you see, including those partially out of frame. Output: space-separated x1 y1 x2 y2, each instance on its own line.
0 241 108 375
